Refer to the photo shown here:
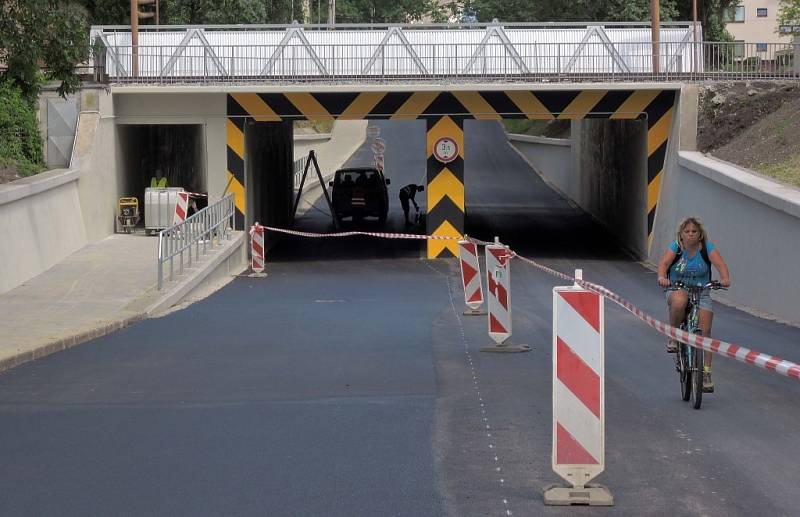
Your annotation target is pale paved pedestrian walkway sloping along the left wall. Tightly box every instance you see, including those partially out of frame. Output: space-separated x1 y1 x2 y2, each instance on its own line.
0 232 245 371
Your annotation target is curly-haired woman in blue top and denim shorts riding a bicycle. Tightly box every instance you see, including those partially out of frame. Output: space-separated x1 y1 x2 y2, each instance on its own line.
658 217 731 393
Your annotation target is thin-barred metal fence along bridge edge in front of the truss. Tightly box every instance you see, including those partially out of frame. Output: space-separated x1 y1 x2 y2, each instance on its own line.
97 41 800 85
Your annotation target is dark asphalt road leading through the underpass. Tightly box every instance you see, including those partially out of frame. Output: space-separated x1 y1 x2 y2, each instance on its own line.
0 122 800 516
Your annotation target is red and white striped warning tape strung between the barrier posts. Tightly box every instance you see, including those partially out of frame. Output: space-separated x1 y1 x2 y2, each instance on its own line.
264 226 800 380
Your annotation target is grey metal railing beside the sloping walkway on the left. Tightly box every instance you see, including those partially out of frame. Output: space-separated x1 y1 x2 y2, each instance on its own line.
158 194 236 291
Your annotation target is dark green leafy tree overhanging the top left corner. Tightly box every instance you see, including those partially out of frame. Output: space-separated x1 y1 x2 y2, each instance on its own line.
0 0 89 98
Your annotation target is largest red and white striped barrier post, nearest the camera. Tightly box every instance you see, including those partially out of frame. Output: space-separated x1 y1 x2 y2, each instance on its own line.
544 270 614 506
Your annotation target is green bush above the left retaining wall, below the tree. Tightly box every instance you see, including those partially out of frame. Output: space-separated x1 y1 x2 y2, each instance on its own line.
0 81 44 176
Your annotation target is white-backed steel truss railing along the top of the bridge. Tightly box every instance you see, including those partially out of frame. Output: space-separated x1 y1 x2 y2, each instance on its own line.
92 23 800 84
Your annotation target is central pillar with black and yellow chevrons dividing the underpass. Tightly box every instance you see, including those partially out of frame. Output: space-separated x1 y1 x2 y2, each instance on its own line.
426 115 464 258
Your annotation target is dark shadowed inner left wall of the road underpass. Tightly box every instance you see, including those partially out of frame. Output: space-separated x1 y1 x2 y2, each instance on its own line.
244 119 294 249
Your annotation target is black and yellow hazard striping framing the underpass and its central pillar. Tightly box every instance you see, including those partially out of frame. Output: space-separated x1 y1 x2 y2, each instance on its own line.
228 90 676 252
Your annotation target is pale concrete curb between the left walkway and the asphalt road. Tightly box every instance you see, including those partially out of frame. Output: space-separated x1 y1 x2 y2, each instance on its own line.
0 232 245 372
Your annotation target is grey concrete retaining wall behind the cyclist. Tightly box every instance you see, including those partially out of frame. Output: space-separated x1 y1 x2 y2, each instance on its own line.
649 151 800 324
